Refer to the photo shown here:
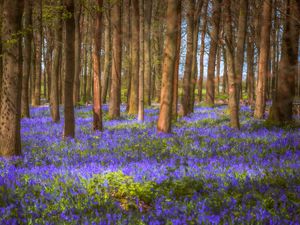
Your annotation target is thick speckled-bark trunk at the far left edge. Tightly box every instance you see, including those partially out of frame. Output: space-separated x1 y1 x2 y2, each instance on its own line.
0 0 24 157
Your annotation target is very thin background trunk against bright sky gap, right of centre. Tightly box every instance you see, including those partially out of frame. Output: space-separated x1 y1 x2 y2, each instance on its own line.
198 0 208 102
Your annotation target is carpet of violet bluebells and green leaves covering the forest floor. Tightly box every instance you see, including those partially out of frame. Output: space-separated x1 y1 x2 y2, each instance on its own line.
0 106 300 225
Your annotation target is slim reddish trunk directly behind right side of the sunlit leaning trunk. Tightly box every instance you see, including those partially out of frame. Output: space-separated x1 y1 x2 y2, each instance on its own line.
172 1 181 120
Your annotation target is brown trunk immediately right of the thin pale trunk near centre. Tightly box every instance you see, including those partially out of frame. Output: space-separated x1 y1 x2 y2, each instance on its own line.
144 0 153 106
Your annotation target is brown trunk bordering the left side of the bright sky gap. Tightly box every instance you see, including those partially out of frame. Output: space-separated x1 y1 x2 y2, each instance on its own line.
181 0 195 116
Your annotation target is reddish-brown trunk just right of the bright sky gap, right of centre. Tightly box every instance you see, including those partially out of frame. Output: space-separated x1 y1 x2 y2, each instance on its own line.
206 0 221 105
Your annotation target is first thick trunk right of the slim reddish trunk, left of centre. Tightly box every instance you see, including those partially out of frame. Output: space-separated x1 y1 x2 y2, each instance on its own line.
109 2 122 119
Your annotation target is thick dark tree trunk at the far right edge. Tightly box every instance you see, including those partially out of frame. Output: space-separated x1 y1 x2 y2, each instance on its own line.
269 0 300 123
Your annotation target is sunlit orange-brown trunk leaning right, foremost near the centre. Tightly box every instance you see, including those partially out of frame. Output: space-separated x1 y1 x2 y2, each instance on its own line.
157 0 179 133
